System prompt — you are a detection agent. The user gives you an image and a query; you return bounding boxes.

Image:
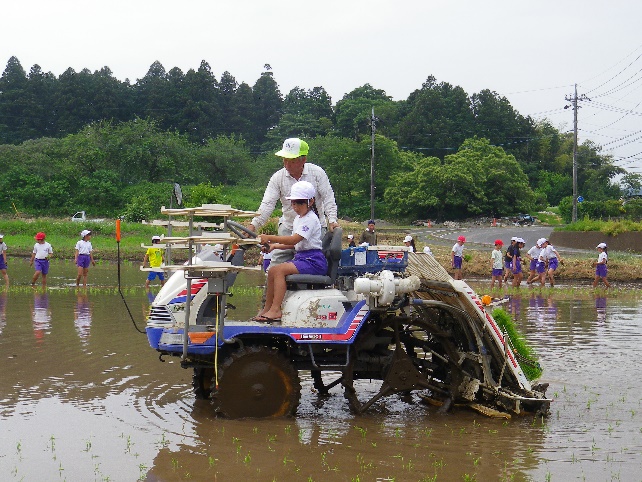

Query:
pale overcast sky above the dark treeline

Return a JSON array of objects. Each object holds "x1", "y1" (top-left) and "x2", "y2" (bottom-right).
[{"x1": 0, "y1": 0, "x2": 642, "y2": 177}]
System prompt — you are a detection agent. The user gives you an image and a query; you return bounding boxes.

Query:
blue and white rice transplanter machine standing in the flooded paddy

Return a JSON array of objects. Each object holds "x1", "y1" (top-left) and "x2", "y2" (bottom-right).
[{"x1": 146, "y1": 203, "x2": 551, "y2": 418}]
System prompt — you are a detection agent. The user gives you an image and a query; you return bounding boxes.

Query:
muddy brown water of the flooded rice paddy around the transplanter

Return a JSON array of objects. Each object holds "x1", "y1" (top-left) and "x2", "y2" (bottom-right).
[{"x1": 0, "y1": 266, "x2": 642, "y2": 481}]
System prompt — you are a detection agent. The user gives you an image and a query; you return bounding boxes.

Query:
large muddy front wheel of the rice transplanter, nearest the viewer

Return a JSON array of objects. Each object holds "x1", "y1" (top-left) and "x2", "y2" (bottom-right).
[{"x1": 212, "y1": 346, "x2": 301, "y2": 418}]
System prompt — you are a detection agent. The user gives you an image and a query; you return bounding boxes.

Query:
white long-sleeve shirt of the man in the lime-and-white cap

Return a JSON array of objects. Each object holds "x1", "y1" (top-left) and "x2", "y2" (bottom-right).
[{"x1": 252, "y1": 162, "x2": 337, "y2": 231}]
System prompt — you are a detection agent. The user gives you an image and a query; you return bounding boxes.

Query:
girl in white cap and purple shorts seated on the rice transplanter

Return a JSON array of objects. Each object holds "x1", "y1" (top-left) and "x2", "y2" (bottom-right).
[{"x1": 253, "y1": 181, "x2": 328, "y2": 323}]
